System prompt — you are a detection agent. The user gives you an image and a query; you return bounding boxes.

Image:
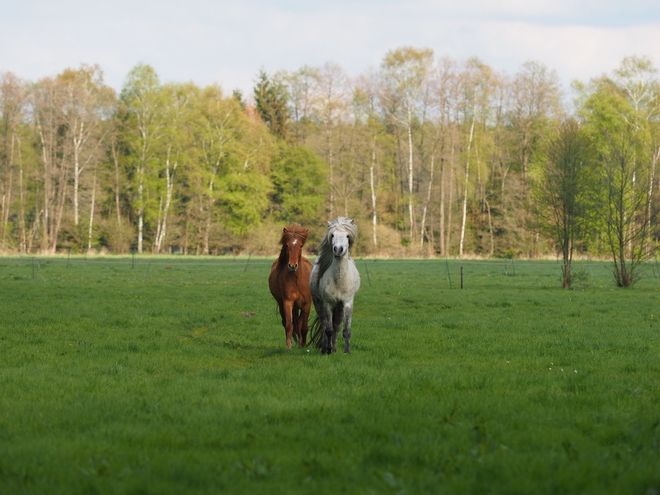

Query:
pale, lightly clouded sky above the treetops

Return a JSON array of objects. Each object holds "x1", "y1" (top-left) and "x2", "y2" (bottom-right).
[{"x1": 0, "y1": 0, "x2": 660, "y2": 95}]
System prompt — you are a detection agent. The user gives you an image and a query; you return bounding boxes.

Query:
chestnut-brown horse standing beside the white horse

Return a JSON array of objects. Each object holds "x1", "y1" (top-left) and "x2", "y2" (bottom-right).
[{"x1": 268, "y1": 225, "x2": 312, "y2": 349}]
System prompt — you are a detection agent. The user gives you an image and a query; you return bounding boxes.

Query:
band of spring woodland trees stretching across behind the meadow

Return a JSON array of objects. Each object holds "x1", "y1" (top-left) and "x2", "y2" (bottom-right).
[{"x1": 0, "y1": 47, "x2": 660, "y2": 276}]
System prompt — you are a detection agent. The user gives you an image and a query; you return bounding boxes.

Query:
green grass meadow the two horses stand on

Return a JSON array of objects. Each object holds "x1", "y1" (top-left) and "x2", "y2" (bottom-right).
[{"x1": 0, "y1": 257, "x2": 660, "y2": 495}]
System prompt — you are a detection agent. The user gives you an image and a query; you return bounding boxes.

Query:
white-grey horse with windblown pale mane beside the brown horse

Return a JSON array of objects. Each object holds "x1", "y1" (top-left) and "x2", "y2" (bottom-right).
[{"x1": 309, "y1": 217, "x2": 360, "y2": 354}]
